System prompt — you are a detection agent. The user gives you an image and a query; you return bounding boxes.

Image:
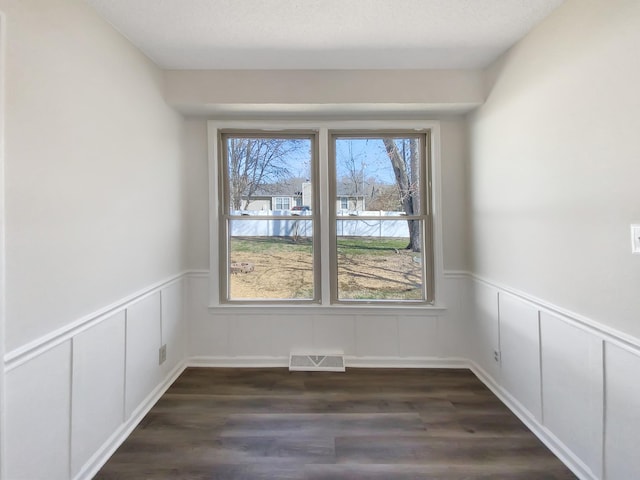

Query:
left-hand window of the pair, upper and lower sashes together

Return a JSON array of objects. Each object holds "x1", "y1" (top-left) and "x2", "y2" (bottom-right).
[{"x1": 220, "y1": 132, "x2": 319, "y2": 301}]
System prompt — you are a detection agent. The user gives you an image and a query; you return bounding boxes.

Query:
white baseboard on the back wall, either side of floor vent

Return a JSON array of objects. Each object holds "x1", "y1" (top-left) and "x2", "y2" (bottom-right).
[{"x1": 186, "y1": 356, "x2": 469, "y2": 368}]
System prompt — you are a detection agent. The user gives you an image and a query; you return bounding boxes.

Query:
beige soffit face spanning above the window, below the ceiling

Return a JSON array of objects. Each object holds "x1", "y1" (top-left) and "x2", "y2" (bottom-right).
[{"x1": 165, "y1": 70, "x2": 484, "y2": 118}]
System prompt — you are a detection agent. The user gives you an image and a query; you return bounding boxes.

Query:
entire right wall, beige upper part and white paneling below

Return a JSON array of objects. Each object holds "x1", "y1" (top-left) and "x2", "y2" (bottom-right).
[{"x1": 468, "y1": 0, "x2": 640, "y2": 480}]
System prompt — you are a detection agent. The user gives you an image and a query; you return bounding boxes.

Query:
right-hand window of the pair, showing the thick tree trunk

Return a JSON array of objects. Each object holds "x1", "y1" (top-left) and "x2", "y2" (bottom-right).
[{"x1": 332, "y1": 133, "x2": 426, "y2": 301}]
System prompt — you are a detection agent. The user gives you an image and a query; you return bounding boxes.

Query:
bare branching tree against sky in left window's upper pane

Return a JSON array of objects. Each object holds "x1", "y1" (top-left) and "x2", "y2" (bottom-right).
[{"x1": 227, "y1": 137, "x2": 305, "y2": 210}]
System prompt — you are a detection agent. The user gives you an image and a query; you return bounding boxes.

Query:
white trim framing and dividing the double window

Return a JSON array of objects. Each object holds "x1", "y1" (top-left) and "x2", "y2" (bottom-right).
[{"x1": 207, "y1": 120, "x2": 444, "y2": 315}]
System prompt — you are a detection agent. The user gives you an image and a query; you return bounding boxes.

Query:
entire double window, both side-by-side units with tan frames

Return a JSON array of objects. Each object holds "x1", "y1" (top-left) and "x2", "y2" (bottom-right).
[{"x1": 212, "y1": 125, "x2": 436, "y2": 306}]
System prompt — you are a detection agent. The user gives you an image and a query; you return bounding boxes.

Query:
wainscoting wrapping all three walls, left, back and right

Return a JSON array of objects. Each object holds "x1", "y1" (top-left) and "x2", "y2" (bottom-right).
[{"x1": 3, "y1": 272, "x2": 640, "y2": 480}]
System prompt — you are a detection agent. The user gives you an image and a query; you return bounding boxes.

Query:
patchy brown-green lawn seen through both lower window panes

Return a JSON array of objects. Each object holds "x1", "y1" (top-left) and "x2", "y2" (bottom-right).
[{"x1": 230, "y1": 237, "x2": 423, "y2": 300}]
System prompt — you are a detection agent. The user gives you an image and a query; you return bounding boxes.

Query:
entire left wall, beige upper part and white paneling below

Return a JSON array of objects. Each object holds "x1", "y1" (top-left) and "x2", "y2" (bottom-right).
[{"x1": 0, "y1": 0, "x2": 187, "y2": 480}]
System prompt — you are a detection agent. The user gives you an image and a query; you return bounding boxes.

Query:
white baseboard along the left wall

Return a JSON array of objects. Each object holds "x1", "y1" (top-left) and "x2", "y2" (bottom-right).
[{"x1": 73, "y1": 362, "x2": 187, "y2": 480}]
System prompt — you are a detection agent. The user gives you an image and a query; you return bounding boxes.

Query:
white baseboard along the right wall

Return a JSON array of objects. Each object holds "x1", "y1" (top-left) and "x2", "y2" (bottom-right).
[{"x1": 467, "y1": 360, "x2": 598, "y2": 480}]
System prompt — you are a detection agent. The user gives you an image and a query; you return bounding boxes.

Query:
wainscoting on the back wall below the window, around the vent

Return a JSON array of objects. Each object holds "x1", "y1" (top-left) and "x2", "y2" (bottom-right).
[{"x1": 188, "y1": 273, "x2": 468, "y2": 367}]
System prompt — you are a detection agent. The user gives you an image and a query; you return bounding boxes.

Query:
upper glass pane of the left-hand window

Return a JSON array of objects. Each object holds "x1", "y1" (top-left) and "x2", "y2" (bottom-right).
[{"x1": 223, "y1": 135, "x2": 313, "y2": 215}]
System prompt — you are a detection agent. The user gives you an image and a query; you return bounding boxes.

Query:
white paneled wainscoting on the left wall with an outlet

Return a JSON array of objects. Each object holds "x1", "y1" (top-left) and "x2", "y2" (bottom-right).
[{"x1": 5, "y1": 275, "x2": 186, "y2": 480}]
